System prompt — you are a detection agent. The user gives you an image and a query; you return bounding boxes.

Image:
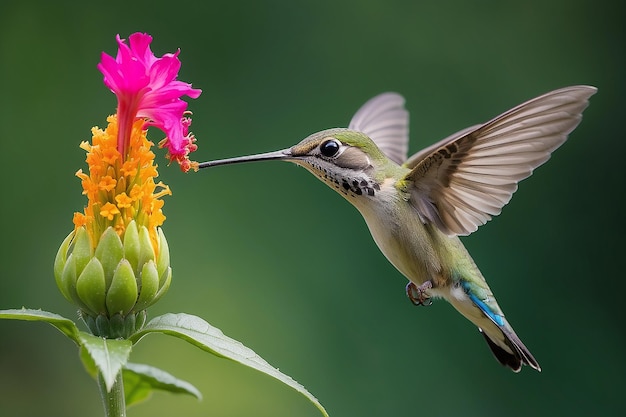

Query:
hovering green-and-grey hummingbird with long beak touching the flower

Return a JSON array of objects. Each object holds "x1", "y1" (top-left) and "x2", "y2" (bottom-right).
[{"x1": 199, "y1": 86, "x2": 596, "y2": 372}]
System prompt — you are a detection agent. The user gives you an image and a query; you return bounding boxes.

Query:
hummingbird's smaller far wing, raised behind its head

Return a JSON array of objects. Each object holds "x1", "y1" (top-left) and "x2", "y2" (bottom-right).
[{"x1": 348, "y1": 93, "x2": 409, "y2": 164}]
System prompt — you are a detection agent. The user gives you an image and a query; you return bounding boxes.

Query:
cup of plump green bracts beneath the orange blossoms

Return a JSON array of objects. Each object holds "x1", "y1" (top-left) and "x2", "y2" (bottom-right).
[{"x1": 54, "y1": 221, "x2": 172, "y2": 338}]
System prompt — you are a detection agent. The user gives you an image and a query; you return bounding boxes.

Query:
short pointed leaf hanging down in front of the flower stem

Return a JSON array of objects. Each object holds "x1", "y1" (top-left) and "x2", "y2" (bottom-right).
[{"x1": 78, "y1": 332, "x2": 133, "y2": 391}]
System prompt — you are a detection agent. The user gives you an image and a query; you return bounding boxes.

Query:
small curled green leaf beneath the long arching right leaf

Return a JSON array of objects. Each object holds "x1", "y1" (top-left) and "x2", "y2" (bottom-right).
[{"x1": 122, "y1": 363, "x2": 202, "y2": 405}]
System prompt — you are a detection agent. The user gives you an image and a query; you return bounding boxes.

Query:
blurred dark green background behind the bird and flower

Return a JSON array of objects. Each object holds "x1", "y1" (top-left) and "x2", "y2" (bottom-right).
[{"x1": 0, "y1": 0, "x2": 626, "y2": 417}]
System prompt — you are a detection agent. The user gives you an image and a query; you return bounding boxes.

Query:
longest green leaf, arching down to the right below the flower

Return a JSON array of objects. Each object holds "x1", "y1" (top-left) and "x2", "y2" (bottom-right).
[{"x1": 130, "y1": 313, "x2": 328, "y2": 417}]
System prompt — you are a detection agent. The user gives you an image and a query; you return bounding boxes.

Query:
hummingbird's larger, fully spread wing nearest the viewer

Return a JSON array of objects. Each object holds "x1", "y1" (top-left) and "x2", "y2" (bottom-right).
[{"x1": 405, "y1": 86, "x2": 596, "y2": 235}]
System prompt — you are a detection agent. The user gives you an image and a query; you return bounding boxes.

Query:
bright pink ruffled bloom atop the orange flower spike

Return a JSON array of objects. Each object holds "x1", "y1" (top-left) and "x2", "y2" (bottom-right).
[{"x1": 98, "y1": 33, "x2": 202, "y2": 172}]
